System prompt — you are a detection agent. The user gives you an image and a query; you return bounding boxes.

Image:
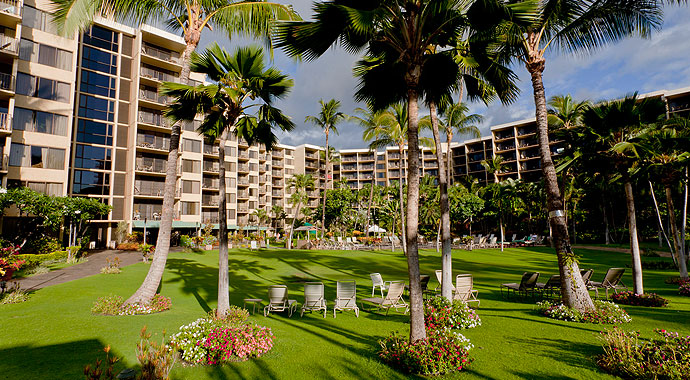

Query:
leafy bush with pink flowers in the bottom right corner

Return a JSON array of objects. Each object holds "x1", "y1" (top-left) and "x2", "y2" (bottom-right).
[{"x1": 597, "y1": 328, "x2": 690, "y2": 379}]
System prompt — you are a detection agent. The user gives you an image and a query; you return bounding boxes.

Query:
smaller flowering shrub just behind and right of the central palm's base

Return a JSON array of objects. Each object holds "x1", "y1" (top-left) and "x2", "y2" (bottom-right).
[{"x1": 424, "y1": 297, "x2": 482, "y2": 330}]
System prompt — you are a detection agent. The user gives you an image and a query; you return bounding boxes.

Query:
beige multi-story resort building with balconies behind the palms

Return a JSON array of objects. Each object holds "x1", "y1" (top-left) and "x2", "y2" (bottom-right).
[{"x1": 0, "y1": 0, "x2": 690, "y2": 246}]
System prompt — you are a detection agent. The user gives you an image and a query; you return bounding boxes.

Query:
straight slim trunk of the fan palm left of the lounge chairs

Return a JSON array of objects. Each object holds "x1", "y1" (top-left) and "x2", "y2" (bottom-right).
[{"x1": 216, "y1": 130, "x2": 230, "y2": 317}]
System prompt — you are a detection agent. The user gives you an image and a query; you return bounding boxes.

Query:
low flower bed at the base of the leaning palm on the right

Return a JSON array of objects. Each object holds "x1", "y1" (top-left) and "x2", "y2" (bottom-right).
[{"x1": 537, "y1": 300, "x2": 632, "y2": 324}]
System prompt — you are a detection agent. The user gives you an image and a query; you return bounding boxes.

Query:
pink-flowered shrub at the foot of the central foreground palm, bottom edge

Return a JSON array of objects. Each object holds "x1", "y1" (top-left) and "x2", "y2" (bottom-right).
[{"x1": 378, "y1": 329, "x2": 473, "y2": 375}]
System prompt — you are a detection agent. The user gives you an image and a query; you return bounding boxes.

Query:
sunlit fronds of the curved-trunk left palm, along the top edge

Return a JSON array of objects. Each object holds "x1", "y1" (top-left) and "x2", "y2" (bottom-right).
[{"x1": 54, "y1": 0, "x2": 300, "y2": 45}]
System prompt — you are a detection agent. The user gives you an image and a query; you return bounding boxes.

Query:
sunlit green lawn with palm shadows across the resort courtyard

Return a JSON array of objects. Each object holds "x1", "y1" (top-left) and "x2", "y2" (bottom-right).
[{"x1": 0, "y1": 248, "x2": 690, "y2": 380}]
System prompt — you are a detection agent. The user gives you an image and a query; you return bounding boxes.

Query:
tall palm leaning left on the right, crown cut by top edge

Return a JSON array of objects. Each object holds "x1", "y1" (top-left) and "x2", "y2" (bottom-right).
[{"x1": 472, "y1": 0, "x2": 662, "y2": 311}]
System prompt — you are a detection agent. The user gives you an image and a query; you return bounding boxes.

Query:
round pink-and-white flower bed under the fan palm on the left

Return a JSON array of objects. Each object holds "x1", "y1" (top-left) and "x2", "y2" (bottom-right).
[{"x1": 168, "y1": 306, "x2": 275, "y2": 365}]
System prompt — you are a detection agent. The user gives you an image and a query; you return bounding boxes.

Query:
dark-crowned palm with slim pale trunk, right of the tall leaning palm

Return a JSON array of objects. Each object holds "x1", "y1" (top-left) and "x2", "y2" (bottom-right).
[{"x1": 574, "y1": 94, "x2": 665, "y2": 294}]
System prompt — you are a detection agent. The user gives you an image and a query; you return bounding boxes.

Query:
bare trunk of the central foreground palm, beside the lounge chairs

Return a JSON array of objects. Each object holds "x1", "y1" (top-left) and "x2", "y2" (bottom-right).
[{"x1": 406, "y1": 81, "x2": 426, "y2": 342}]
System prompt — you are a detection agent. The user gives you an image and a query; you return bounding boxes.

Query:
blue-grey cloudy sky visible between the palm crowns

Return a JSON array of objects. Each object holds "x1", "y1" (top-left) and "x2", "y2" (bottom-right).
[{"x1": 200, "y1": 0, "x2": 690, "y2": 149}]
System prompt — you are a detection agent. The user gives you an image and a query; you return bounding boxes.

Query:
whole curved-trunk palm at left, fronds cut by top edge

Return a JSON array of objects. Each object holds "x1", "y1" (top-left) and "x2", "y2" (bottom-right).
[{"x1": 54, "y1": 0, "x2": 300, "y2": 304}]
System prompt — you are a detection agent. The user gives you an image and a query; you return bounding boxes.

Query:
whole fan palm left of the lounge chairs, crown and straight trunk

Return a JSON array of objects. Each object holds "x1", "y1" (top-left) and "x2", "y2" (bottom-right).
[{"x1": 161, "y1": 44, "x2": 294, "y2": 315}]
